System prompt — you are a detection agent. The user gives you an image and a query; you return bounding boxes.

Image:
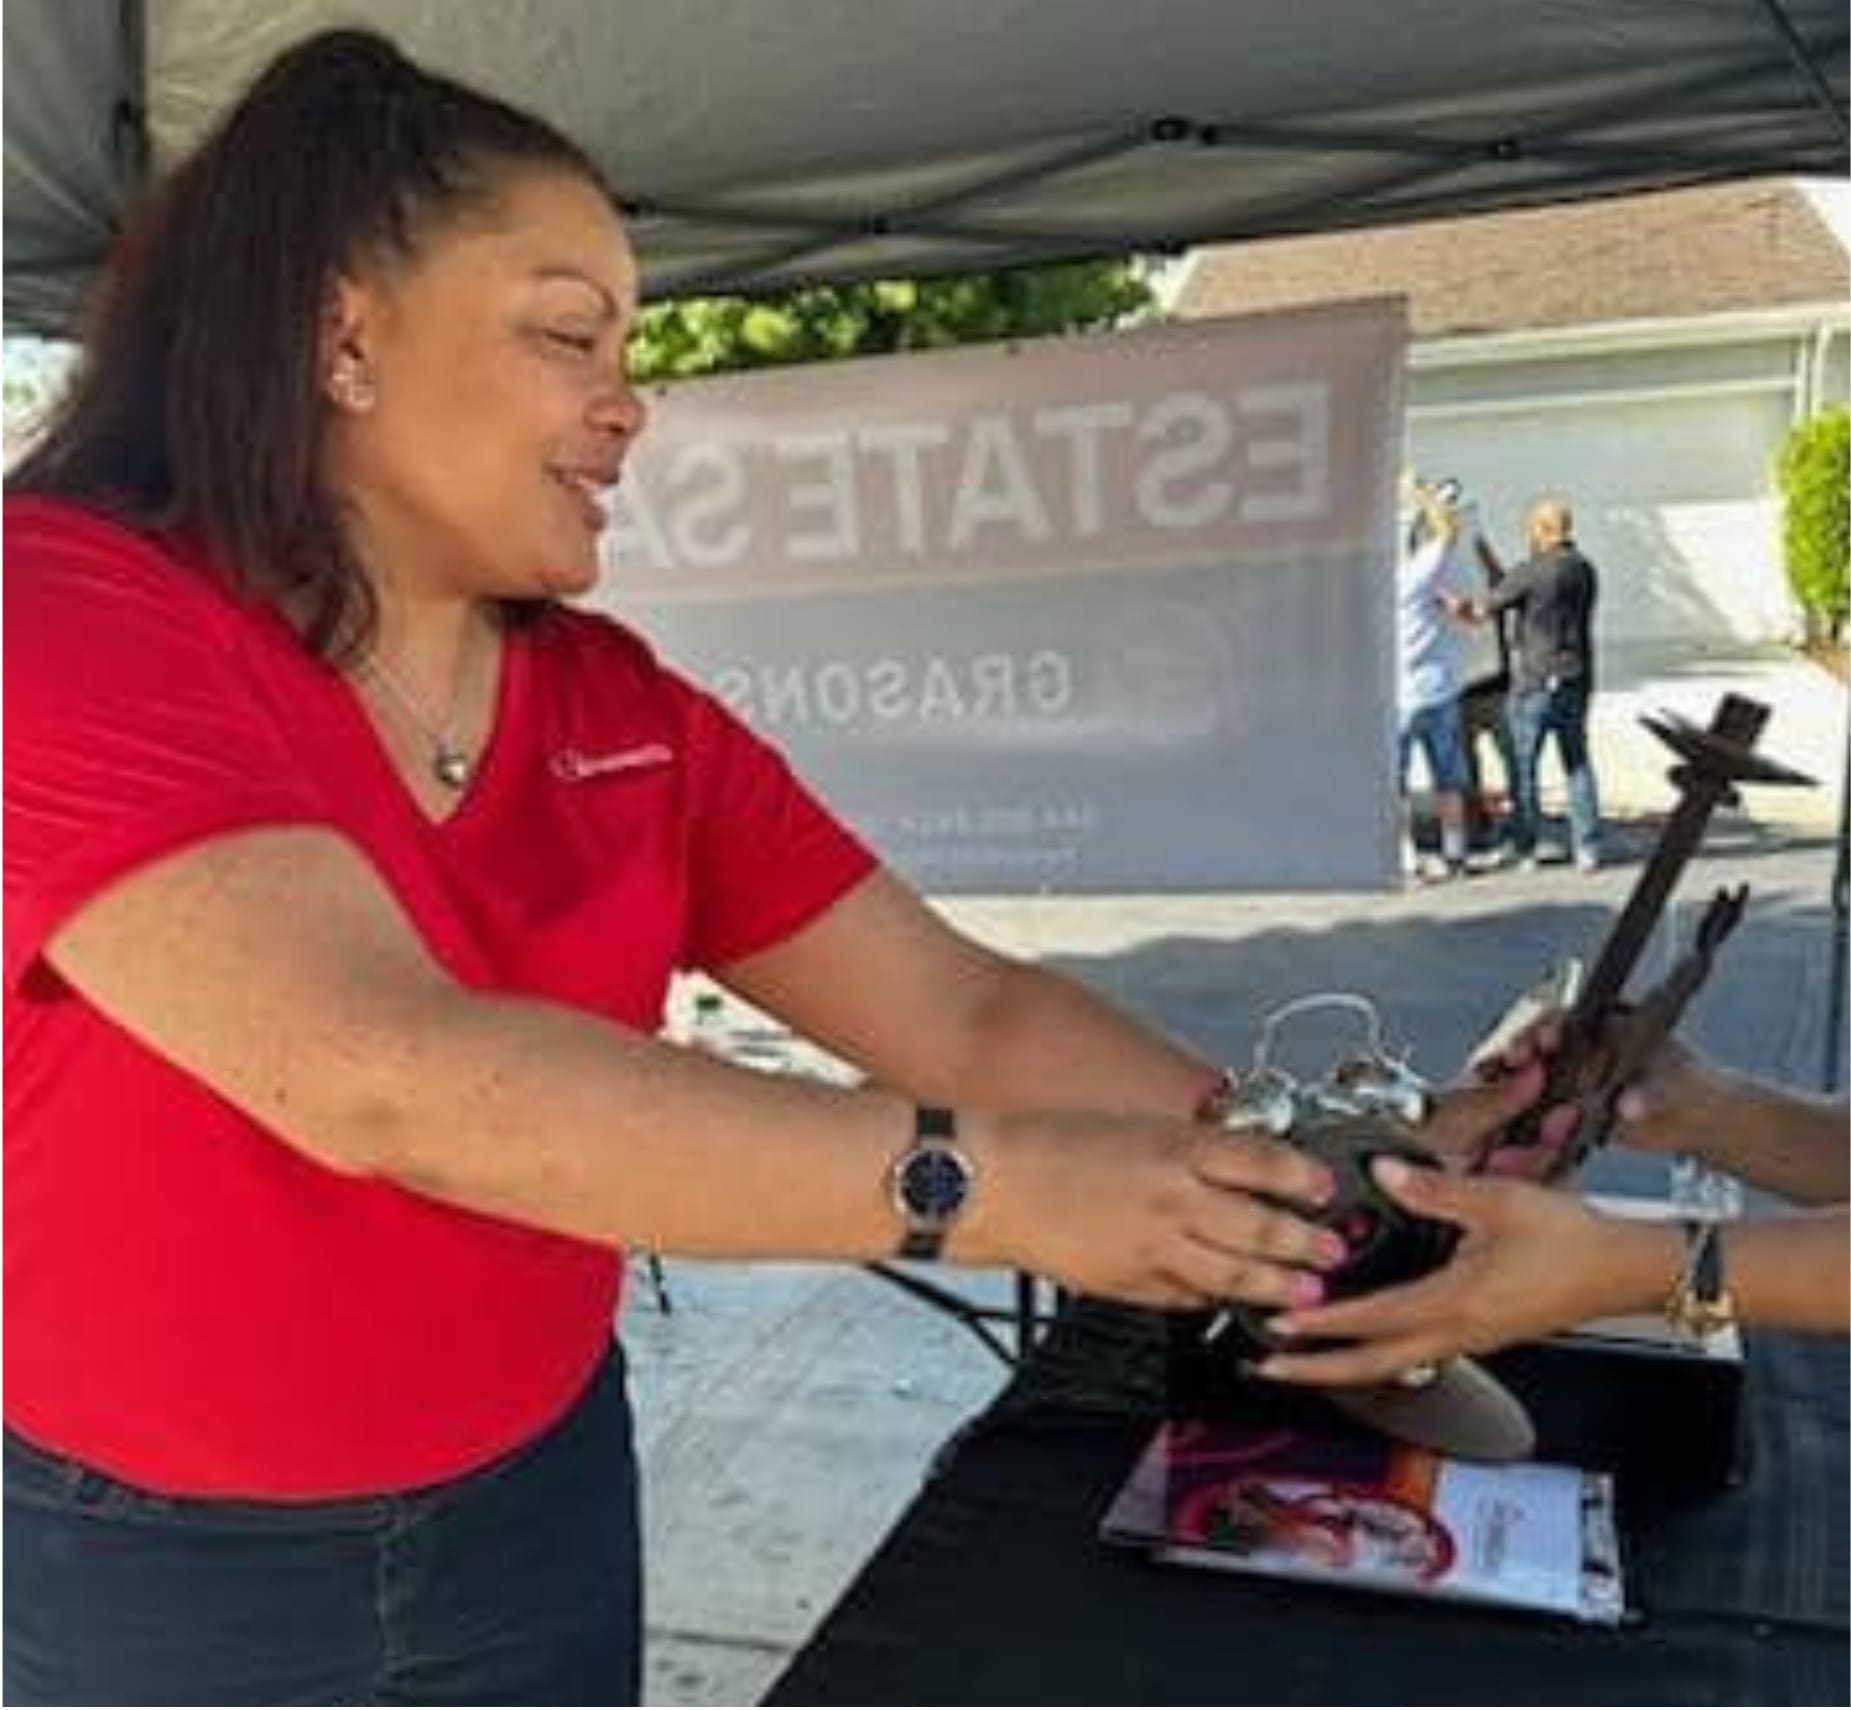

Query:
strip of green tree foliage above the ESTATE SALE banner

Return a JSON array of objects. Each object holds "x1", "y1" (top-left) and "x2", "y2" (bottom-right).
[{"x1": 629, "y1": 261, "x2": 1153, "y2": 381}]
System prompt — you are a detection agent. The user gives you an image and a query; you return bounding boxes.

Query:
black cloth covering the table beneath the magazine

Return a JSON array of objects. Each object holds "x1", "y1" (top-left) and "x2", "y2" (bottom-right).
[{"x1": 766, "y1": 1301, "x2": 1851, "y2": 1704}]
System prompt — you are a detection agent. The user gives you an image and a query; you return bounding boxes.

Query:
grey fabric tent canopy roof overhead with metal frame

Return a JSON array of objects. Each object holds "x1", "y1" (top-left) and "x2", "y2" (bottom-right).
[{"x1": 6, "y1": 0, "x2": 1851, "y2": 331}]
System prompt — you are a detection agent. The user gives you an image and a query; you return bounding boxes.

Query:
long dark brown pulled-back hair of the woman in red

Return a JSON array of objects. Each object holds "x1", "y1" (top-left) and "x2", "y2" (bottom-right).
[{"x1": 6, "y1": 30, "x2": 615, "y2": 657}]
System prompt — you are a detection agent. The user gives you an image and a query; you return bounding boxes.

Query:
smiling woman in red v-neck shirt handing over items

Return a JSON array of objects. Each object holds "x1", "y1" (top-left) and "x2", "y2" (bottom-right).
[{"x1": 6, "y1": 31, "x2": 1532, "y2": 1703}]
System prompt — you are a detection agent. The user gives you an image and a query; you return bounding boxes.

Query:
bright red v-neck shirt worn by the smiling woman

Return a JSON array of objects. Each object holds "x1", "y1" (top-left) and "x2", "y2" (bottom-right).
[{"x1": 6, "y1": 498, "x2": 874, "y2": 1499}]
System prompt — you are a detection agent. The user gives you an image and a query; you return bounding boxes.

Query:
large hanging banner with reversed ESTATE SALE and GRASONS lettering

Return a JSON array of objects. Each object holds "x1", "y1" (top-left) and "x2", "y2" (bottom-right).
[{"x1": 607, "y1": 304, "x2": 1401, "y2": 894}]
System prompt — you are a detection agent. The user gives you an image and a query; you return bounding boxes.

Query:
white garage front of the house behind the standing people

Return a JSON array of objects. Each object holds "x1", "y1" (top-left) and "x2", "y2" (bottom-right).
[{"x1": 1409, "y1": 305, "x2": 1851, "y2": 650}]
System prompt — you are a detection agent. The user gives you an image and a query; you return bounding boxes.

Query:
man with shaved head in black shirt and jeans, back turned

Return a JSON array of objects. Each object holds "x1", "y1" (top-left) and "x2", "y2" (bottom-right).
[{"x1": 1457, "y1": 498, "x2": 1601, "y2": 872}]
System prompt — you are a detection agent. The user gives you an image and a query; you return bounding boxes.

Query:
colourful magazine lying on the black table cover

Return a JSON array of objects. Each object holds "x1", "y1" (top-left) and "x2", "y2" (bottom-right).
[{"x1": 1099, "y1": 1421, "x2": 1625, "y2": 1625}]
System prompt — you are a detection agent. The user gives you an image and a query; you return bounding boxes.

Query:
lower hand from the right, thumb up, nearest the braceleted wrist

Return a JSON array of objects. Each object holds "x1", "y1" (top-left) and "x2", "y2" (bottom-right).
[{"x1": 1257, "y1": 1159, "x2": 1681, "y2": 1386}]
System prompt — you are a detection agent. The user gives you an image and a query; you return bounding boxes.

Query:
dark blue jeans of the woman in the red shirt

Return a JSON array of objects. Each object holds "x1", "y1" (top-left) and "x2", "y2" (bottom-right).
[{"x1": 4, "y1": 1347, "x2": 642, "y2": 1704}]
